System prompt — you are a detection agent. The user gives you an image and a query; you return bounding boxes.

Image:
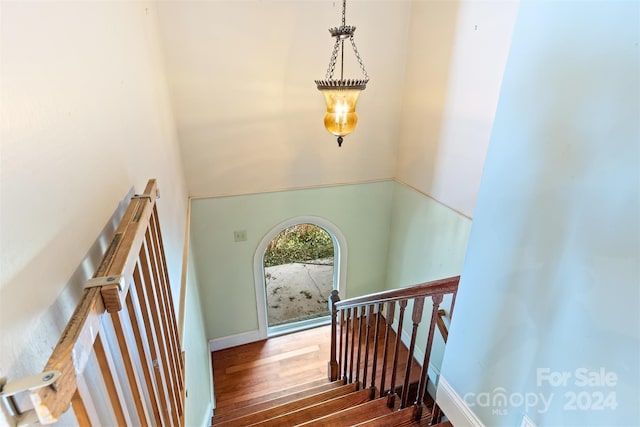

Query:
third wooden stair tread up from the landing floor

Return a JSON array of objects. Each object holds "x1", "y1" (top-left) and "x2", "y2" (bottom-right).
[{"x1": 252, "y1": 389, "x2": 371, "y2": 427}]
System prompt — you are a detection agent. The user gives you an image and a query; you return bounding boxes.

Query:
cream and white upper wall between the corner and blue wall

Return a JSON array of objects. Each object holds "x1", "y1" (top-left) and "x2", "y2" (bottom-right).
[{"x1": 396, "y1": 0, "x2": 518, "y2": 217}]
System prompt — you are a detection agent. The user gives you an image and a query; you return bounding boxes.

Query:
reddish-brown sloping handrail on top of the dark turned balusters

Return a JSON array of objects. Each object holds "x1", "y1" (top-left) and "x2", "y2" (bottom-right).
[{"x1": 336, "y1": 276, "x2": 460, "y2": 309}]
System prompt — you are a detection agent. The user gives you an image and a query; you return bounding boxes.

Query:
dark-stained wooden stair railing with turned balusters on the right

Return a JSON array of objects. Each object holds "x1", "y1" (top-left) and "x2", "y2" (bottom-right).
[{"x1": 328, "y1": 276, "x2": 460, "y2": 419}]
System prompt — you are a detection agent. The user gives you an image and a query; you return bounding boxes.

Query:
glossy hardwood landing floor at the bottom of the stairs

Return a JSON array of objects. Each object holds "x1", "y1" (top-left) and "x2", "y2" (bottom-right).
[{"x1": 212, "y1": 326, "x2": 420, "y2": 414}]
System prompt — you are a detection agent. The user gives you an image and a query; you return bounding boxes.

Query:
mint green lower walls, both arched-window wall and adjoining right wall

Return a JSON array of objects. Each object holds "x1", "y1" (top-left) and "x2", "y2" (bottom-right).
[{"x1": 191, "y1": 181, "x2": 471, "y2": 364}]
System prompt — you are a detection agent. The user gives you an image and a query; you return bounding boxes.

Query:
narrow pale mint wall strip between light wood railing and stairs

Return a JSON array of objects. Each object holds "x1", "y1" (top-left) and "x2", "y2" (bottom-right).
[{"x1": 182, "y1": 244, "x2": 214, "y2": 426}]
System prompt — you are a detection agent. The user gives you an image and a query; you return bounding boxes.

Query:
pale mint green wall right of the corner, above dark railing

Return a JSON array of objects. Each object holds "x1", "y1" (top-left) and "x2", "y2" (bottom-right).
[{"x1": 386, "y1": 183, "x2": 471, "y2": 381}]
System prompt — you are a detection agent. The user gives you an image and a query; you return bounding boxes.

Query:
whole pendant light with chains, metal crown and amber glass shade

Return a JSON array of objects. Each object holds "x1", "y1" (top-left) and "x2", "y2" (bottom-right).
[{"x1": 315, "y1": 0, "x2": 369, "y2": 147}]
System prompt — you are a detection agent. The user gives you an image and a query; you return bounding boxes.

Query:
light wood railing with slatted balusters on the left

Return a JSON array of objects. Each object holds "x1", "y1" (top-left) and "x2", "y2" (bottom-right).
[{"x1": 0, "y1": 180, "x2": 185, "y2": 426}]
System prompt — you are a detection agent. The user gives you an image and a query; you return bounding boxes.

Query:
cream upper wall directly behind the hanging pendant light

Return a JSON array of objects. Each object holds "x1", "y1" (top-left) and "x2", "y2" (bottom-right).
[{"x1": 158, "y1": 0, "x2": 411, "y2": 197}]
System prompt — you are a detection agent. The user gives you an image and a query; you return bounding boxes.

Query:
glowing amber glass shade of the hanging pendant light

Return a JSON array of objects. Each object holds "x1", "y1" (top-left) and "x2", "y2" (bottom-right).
[{"x1": 321, "y1": 88, "x2": 361, "y2": 137}]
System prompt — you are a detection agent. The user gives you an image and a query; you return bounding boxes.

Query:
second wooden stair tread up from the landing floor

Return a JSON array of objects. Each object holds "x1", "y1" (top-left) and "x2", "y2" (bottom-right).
[{"x1": 214, "y1": 383, "x2": 358, "y2": 427}]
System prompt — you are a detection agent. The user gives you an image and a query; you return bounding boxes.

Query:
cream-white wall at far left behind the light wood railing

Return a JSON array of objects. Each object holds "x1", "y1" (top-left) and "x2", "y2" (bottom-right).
[{"x1": 0, "y1": 2, "x2": 204, "y2": 424}]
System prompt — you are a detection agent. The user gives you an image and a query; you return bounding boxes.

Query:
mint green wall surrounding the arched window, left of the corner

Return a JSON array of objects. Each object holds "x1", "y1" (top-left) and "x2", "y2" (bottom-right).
[{"x1": 191, "y1": 181, "x2": 394, "y2": 339}]
